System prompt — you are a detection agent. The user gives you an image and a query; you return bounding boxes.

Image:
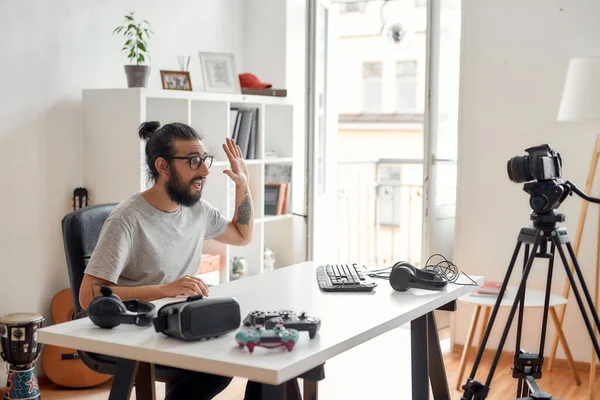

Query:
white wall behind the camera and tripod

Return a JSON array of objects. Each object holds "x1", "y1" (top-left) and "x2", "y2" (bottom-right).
[{"x1": 454, "y1": 0, "x2": 600, "y2": 368}]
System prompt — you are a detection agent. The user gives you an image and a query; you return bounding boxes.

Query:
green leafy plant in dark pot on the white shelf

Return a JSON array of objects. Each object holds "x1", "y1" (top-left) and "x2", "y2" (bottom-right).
[{"x1": 113, "y1": 12, "x2": 154, "y2": 87}]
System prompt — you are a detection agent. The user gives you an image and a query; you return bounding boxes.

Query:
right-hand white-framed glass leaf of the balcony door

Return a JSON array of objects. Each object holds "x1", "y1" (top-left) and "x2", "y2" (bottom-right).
[{"x1": 423, "y1": 0, "x2": 461, "y2": 261}]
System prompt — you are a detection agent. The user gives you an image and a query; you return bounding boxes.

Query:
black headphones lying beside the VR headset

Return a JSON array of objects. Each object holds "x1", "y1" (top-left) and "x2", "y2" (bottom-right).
[{"x1": 88, "y1": 286, "x2": 156, "y2": 329}]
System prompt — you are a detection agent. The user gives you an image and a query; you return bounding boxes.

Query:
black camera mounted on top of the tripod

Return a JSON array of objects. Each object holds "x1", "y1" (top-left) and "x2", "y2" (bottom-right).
[{"x1": 506, "y1": 144, "x2": 562, "y2": 183}]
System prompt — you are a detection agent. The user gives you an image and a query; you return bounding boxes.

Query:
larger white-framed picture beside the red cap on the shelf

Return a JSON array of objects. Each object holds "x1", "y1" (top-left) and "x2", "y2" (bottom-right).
[{"x1": 200, "y1": 53, "x2": 241, "y2": 93}]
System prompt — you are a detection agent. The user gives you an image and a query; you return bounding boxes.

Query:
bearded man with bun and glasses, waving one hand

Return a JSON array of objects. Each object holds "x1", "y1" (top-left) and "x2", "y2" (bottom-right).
[{"x1": 79, "y1": 121, "x2": 260, "y2": 400}]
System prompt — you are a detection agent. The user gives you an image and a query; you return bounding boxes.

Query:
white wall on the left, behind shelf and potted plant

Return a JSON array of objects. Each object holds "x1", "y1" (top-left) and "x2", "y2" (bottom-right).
[{"x1": 0, "y1": 0, "x2": 245, "y2": 376}]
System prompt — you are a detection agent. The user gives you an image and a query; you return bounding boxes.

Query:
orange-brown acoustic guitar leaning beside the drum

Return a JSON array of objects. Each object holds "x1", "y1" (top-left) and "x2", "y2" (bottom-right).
[{"x1": 42, "y1": 289, "x2": 112, "y2": 388}]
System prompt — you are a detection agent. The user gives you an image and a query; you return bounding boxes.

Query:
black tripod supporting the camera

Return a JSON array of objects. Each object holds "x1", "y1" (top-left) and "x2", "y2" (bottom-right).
[{"x1": 461, "y1": 181, "x2": 600, "y2": 400}]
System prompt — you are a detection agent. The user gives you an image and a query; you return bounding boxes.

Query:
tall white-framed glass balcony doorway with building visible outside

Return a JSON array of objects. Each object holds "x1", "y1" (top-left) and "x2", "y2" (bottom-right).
[{"x1": 307, "y1": 0, "x2": 460, "y2": 282}]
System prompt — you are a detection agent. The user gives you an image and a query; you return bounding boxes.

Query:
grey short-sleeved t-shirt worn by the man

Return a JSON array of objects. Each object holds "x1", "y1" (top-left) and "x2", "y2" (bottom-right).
[{"x1": 85, "y1": 193, "x2": 227, "y2": 286}]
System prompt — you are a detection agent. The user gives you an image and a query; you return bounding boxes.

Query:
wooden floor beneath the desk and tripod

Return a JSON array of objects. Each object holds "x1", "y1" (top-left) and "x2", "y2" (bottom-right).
[{"x1": 19, "y1": 327, "x2": 600, "y2": 400}]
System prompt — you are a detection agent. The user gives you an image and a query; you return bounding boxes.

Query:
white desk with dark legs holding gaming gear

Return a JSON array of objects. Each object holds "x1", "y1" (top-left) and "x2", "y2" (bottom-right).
[{"x1": 38, "y1": 262, "x2": 483, "y2": 398}]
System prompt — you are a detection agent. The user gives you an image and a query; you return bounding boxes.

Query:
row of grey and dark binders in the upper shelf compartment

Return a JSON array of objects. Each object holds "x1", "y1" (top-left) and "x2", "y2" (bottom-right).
[{"x1": 229, "y1": 107, "x2": 259, "y2": 160}]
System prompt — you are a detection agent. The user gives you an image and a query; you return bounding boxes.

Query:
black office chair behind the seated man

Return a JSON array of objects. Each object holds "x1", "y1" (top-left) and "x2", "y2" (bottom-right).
[{"x1": 62, "y1": 203, "x2": 176, "y2": 385}]
